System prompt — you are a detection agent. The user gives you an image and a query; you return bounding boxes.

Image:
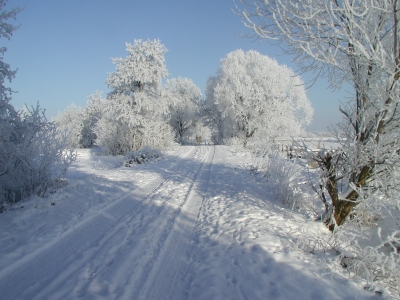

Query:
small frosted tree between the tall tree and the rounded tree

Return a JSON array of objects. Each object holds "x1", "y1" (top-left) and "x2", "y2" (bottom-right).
[{"x1": 164, "y1": 77, "x2": 202, "y2": 143}]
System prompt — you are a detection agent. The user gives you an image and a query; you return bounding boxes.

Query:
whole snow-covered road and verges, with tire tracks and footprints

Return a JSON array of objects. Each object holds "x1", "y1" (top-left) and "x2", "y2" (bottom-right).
[{"x1": 0, "y1": 146, "x2": 373, "y2": 299}]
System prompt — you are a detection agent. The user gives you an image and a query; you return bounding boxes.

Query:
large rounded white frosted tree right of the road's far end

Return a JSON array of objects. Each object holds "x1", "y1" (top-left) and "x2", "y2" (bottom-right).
[{"x1": 207, "y1": 50, "x2": 313, "y2": 146}]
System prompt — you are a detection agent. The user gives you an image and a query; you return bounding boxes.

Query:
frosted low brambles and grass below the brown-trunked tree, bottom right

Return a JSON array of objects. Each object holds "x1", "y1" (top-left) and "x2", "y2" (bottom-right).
[{"x1": 296, "y1": 179, "x2": 400, "y2": 298}]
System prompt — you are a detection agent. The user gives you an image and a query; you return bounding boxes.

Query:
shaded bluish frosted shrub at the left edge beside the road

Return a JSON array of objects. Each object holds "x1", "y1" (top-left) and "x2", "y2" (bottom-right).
[{"x1": 0, "y1": 106, "x2": 76, "y2": 203}]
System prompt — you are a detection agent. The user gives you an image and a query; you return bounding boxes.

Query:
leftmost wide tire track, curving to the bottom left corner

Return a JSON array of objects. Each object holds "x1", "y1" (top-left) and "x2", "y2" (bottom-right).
[{"x1": 0, "y1": 148, "x2": 199, "y2": 299}]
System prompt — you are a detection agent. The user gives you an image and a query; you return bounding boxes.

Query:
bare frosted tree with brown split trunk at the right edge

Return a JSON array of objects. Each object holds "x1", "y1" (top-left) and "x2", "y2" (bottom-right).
[{"x1": 238, "y1": 0, "x2": 400, "y2": 230}]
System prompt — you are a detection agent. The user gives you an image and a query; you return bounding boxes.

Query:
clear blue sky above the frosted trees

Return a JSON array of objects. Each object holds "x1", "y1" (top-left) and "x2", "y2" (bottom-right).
[{"x1": 1, "y1": 0, "x2": 347, "y2": 131}]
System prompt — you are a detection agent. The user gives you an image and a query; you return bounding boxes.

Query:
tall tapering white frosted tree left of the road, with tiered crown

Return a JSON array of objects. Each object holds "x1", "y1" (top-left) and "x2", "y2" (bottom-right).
[{"x1": 93, "y1": 40, "x2": 173, "y2": 155}]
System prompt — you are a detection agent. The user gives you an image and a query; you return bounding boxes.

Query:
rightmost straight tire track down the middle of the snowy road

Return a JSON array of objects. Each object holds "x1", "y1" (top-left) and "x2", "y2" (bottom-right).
[{"x1": 133, "y1": 146, "x2": 215, "y2": 299}]
